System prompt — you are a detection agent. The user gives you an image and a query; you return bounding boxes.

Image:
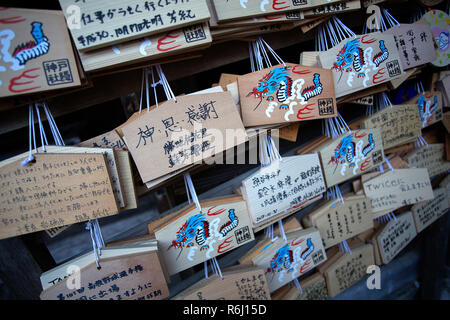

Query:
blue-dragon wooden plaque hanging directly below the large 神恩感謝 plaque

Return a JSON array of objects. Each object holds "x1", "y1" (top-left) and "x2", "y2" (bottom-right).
[{"x1": 154, "y1": 197, "x2": 254, "y2": 275}]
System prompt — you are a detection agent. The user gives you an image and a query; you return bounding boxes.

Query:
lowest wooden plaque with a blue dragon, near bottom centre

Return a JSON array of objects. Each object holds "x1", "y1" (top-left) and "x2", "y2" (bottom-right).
[{"x1": 252, "y1": 228, "x2": 327, "y2": 292}]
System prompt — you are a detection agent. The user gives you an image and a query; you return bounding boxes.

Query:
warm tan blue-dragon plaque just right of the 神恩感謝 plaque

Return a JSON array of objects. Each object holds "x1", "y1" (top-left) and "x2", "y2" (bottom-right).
[{"x1": 238, "y1": 63, "x2": 337, "y2": 127}]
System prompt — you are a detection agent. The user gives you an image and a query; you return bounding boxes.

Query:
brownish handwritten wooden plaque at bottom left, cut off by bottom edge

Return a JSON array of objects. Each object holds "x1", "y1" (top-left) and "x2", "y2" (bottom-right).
[{"x1": 41, "y1": 251, "x2": 169, "y2": 300}]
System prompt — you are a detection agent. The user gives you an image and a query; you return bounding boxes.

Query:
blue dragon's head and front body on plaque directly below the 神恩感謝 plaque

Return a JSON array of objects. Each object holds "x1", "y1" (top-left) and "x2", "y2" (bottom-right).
[{"x1": 167, "y1": 213, "x2": 210, "y2": 256}]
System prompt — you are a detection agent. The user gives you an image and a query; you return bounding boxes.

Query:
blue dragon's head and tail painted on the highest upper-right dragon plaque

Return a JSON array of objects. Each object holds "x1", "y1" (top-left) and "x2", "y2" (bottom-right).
[{"x1": 332, "y1": 39, "x2": 389, "y2": 78}]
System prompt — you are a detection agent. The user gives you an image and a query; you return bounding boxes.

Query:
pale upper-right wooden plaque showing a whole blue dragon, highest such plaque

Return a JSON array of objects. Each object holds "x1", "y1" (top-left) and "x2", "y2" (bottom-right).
[{"x1": 319, "y1": 32, "x2": 403, "y2": 98}]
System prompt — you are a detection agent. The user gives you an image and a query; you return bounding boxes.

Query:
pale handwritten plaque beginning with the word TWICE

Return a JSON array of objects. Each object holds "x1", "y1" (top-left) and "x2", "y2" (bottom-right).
[{"x1": 363, "y1": 168, "x2": 433, "y2": 212}]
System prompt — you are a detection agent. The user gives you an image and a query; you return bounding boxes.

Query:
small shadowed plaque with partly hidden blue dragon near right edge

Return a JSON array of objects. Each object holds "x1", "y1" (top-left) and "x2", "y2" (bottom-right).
[{"x1": 407, "y1": 91, "x2": 443, "y2": 128}]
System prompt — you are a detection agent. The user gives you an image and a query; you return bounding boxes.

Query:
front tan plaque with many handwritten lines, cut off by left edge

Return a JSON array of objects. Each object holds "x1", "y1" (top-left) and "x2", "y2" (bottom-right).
[{"x1": 0, "y1": 153, "x2": 118, "y2": 239}]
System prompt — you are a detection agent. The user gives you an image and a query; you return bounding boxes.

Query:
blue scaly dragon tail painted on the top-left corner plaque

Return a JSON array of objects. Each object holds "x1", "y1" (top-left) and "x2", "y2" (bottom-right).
[{"x1": 12, "y1": 22, "x2": 50, "y2": 65}]
